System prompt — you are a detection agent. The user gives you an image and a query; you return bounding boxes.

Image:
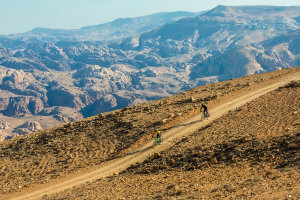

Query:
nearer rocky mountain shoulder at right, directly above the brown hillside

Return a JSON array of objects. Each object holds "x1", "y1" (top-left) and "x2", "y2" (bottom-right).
[{"x1": 190, "y1": 30, "x2": 300, "y2": 81}]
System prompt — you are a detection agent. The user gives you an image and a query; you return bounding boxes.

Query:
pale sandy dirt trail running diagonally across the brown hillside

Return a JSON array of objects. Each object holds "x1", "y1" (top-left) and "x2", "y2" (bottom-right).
[{"x1": 11, "y1": 73, "x2": 300, "y2": 200}]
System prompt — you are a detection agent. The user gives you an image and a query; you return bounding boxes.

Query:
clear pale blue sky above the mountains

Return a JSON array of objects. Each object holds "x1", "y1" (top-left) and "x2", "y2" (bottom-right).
[{"x1": 0, "y1": 0, "x2": 300, "y2": 35}]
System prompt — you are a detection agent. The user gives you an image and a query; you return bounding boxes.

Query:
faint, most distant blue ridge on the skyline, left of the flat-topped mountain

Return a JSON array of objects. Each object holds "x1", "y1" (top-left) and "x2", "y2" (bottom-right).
[{"x1": 1, "y1": 11, "x2": 203, "y2": 43}]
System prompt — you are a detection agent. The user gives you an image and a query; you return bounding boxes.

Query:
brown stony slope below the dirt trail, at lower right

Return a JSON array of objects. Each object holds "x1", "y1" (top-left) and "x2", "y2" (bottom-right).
[{"x1": 48, "y1": 82, "x2": 300, "y2": 200}]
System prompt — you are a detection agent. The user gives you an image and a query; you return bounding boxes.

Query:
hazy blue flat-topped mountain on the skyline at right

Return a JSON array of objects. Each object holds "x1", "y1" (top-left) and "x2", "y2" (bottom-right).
[{"x1": 115, "y1": 6, "x2": 300, "y2": 53}]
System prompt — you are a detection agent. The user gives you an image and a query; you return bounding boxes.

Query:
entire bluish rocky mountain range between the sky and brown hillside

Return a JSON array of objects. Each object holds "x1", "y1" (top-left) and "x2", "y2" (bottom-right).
[{"x1": 0, "y1": 6, "x2": 300, "y2": 139}]
